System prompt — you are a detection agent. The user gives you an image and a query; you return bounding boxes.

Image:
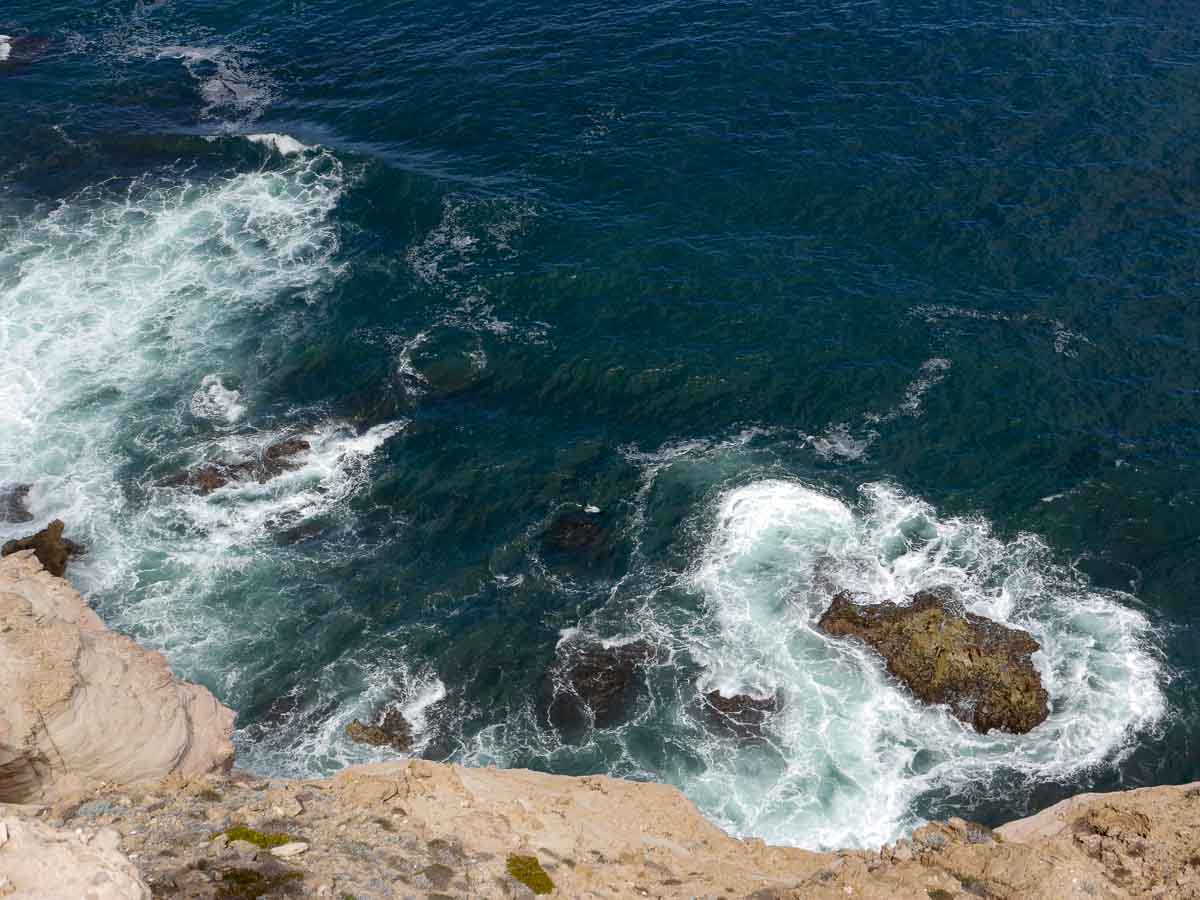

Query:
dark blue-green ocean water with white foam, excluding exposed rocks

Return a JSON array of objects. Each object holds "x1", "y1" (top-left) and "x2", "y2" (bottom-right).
[{"x1": 0, "y1": 0, "x2": 1200, "y2": 847}]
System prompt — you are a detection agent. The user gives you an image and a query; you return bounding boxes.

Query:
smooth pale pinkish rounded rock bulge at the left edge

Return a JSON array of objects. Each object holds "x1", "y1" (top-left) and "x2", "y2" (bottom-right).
[{"x1": 0, "y1": 550, "x2": 234, "y2": 803}]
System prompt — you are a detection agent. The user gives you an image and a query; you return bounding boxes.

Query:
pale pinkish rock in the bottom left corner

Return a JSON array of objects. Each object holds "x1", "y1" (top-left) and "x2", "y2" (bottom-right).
[{"x1": 0, "y1": 816, "x2": 150, "y2": 900}]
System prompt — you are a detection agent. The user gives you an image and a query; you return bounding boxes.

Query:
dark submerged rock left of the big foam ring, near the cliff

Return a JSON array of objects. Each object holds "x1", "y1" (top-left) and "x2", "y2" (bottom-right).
[{"x1": 550, "y1": 641, "x2": 654, "y2": 728}]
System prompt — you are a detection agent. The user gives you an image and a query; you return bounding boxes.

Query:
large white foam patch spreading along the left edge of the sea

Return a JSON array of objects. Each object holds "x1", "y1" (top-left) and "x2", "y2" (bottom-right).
[{"x1": 0, "y1": 151, "x2": 379, "y2": 673}]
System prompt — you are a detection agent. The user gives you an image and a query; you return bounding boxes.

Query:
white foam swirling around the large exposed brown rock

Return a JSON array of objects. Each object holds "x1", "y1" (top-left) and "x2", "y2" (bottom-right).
[{"x1": 680, "y1": 480, "x2": 1165, "y2": 847}]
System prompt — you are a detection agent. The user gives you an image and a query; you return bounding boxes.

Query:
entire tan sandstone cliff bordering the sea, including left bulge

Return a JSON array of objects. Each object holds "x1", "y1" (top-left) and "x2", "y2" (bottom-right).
[{"x1": 0, "y1": 552, "x2": 1200, "y2": 900}]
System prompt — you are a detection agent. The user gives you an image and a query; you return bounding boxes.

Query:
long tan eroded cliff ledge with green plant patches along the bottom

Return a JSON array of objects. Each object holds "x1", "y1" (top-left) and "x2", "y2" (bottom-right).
[{"x1": 9, "y1": 760, "x2": 1200, "y2": 900}]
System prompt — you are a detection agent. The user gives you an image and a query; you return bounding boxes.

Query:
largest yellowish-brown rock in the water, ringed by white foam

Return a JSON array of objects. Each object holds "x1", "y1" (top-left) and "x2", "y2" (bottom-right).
[{"x1": 817, "y1": 588, "x2": 1050, "y2": 734}]
